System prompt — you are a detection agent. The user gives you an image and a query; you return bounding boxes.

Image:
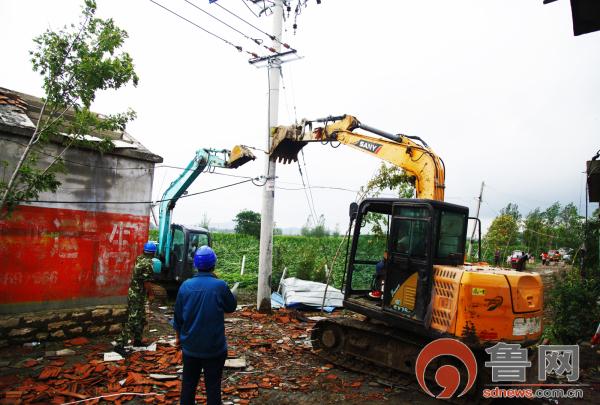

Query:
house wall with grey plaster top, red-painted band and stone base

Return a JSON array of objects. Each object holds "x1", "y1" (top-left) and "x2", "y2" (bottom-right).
[{"x1": 0, "y1": 89, "x2": 162, "y2": 344}]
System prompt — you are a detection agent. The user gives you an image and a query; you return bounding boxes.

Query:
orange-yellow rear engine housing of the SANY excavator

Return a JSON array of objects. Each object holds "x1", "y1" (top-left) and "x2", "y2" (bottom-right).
[{"x1": 430, "y1": 265, "x2": 543, "y2": 343}]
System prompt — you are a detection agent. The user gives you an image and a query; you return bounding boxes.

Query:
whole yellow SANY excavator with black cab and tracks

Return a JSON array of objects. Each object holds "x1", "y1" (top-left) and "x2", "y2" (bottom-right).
[{"x1": 270, "y1": 115, "x2": 543, "y2": 380}]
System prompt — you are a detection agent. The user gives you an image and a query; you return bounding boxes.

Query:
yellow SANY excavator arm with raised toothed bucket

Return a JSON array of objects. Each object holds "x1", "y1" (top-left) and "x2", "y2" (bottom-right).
[{"x1": 270, "y1": 115, "x2": 444, "y2": 201}]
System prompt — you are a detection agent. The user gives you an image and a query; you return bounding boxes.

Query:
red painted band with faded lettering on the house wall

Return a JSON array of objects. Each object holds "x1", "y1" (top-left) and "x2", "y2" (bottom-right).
[{"x1": 0, "y1": 206, "x2": 149, "y2": 304}]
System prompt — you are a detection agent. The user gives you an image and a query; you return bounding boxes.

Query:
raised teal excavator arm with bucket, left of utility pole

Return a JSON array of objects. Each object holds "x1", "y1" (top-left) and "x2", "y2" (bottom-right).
[{"x1": 158, "y1": 145, "x2": 256, "y2": 267}]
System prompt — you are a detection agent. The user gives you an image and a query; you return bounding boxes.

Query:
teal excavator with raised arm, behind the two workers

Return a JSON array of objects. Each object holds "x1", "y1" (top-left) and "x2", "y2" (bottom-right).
[{"x1": 152, "y1": 145, "x2": 256, "y2": 296}]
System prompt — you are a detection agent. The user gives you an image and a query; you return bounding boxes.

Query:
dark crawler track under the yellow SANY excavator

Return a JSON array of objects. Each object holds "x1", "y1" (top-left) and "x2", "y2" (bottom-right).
[{"x1": 311, "y1": 318, "x2": 494, "y2": 404}]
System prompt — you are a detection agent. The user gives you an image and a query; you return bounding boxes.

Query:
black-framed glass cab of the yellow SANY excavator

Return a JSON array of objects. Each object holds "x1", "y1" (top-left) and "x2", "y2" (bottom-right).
[{"x1": 344, "y1": 199, "x2": 468, "y2": 332}]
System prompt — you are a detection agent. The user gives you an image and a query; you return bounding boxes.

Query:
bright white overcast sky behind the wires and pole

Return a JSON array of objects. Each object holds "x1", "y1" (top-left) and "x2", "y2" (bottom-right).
[{"x1": 0, "y1": 0, "x2": 600, "y2": 229}]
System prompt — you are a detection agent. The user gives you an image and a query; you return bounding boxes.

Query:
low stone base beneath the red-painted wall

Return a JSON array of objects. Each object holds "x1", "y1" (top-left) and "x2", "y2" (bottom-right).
[{"x1": 0, "y1": 305, "x2": 127, "y2": 347}]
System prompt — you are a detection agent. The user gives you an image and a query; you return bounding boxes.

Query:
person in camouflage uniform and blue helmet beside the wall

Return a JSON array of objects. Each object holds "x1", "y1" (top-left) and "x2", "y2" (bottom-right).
[{"x1": 117, "y1": 242, "x2": 156, "y2": 350}]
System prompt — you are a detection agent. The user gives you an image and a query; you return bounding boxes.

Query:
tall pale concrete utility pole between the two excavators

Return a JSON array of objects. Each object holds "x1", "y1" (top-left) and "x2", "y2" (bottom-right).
[{"x1": 256, "y1": 0, "x2": 283, "y2": 313}]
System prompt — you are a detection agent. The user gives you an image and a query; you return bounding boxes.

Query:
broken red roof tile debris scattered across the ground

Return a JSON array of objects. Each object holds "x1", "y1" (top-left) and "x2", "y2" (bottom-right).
[{"x1": 0, "y1": 310, "x2": 408, "y2": 405}]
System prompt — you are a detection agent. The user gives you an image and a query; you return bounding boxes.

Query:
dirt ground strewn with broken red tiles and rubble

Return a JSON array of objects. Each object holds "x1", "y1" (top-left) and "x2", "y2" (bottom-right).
[{"x1": 0, "y1": 267, "x2": 600, "y2": 405}]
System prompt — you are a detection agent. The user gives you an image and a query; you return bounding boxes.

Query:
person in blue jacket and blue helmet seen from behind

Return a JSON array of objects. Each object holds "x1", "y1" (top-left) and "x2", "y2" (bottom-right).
[{"x1": 172, "y1": 246, "x2": 237, "y2": 405}]
